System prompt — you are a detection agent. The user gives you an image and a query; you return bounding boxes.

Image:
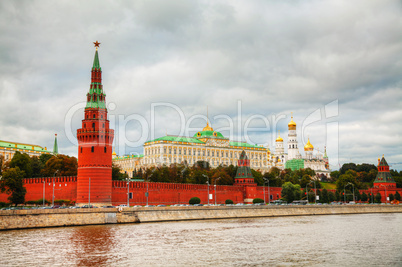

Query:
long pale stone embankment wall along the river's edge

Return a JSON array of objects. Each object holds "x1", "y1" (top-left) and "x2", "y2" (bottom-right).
[{"x1": 0, "y1": 205, "x2": 402, "y2": 230}]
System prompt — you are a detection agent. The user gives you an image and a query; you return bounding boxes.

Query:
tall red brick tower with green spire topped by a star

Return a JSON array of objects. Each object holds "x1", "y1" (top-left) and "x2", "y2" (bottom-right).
[{"x1": 77, "y1": 41, "x2": 114, "y2": 205}]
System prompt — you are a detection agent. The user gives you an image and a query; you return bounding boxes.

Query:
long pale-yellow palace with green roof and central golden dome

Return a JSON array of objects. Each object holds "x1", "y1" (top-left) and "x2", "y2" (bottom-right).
[{"x1": 113, "y1": 123, "x2": 271, "y2": 177}]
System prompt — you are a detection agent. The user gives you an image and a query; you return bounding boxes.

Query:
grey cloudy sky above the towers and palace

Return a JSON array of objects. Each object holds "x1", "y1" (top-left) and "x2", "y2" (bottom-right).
[{"x1": 0, "y1": 0, "x2": 402, "y2": 170}]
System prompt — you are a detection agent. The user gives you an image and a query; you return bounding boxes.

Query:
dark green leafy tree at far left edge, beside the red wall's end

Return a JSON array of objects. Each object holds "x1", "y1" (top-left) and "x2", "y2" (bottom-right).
[{"x1": 0, "y1": 166, "x2": 27, "y2": 205}]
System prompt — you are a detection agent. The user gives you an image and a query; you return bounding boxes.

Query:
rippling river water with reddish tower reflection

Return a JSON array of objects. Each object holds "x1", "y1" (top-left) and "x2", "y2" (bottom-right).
[{"x1": 0, "y1": 213, "x2": 402, "y2": 266}]
